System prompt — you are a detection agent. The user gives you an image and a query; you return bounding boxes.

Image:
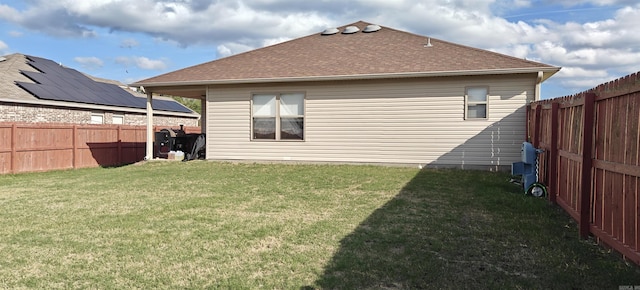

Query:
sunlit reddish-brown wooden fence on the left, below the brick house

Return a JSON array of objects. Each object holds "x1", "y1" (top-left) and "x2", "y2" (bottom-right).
[{"x1": 0, "y1": 123, "x2": 200, "y2": 174}]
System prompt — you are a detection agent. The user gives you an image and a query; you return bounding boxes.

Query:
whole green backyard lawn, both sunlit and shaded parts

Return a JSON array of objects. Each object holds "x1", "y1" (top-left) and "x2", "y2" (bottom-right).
[{"x1": 0, "y1": 161, "x2": 640, "y2": 289}]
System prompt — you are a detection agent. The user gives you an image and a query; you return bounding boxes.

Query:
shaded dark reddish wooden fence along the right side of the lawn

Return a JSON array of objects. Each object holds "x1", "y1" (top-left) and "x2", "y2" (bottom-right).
[{"x1": 527, "y1": 73, "x2": 640, "y2": 265}]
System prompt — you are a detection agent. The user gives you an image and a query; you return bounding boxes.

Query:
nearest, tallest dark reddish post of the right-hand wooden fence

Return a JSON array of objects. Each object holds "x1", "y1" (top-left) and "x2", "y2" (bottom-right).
[{"x1": 579, "y1": 93, "x2": 595, "y2": 239}]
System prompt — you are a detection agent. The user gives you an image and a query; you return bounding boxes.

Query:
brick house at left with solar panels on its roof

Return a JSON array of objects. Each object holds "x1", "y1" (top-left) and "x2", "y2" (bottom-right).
[{"x1": 0, "y1": 54, "x2": 200, "y2": 128}]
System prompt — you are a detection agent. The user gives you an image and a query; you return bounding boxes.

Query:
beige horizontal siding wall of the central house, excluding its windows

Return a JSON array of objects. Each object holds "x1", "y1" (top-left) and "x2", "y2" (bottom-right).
[{"x1": 206, "y1": 74, "x2": 536, "y2": 170}]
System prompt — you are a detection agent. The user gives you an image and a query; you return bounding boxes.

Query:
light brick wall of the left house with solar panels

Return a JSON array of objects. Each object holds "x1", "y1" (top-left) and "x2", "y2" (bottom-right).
[{"x1": 0, "y1": 103, "x2": 198, "y2": 127}]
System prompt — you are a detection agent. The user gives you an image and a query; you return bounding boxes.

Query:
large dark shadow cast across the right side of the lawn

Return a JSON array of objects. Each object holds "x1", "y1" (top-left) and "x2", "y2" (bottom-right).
[{"x1": 302, "y1": 170, "x2": 638, "y2": 289}]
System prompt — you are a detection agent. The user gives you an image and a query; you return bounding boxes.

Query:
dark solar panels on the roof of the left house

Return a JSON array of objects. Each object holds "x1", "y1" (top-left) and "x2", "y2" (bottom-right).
[{"x1": 16, "y1": 56, "x2": 191, "y2": 113}]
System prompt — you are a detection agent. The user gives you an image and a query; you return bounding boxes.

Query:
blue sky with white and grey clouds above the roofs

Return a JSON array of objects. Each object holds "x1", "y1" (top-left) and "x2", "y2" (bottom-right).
[{"x1": 0, "y1": 0, "x2": 640, "y2": 99}]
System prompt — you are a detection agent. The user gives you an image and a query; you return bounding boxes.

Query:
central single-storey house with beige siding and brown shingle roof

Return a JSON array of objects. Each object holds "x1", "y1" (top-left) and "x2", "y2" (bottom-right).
[{"x1": 133, "y1": 22, "x2": 560, "y2": 170}]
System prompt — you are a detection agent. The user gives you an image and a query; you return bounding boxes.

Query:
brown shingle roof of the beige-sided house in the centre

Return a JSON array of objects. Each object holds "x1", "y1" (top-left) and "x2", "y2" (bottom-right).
[{"x1": 134, "y1": 21, "x2": 559, "y2": 85}]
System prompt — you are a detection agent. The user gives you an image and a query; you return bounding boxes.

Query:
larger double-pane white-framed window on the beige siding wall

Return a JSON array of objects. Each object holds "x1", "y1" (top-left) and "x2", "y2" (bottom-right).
[{"x1": 251, "y1": 93, "x2": 304, "y2": 140}]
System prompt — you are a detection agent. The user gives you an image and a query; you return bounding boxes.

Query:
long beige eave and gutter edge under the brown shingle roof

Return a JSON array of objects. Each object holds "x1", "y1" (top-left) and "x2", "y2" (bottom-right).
[{"x1": 130, "y1": 66, "x2": 560, "y2": 88}]
